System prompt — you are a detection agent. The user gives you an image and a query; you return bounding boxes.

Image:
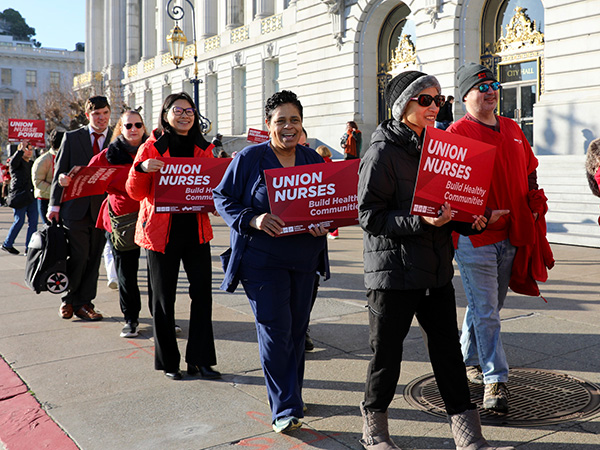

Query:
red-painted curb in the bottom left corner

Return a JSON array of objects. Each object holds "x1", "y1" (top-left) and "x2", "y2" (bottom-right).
[{"x1": 0, "y1": 358, "x2": 79, "y2": 450}]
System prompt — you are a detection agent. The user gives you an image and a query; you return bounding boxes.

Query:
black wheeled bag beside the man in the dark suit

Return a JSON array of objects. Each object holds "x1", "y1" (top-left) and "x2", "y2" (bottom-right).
[{"x1": 25, "y1": 221, "x2": 69, "y2": 294}]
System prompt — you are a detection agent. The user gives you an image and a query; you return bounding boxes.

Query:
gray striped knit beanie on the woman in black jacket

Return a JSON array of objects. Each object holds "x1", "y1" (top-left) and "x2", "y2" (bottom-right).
[{"x1": 383, "y1": 70, "x2": 442, "y2": 121}]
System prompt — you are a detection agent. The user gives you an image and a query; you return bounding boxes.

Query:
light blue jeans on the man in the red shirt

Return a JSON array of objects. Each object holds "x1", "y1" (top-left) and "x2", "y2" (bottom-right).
[{"x1": 454, "y1": 236, "x2": 516, "y2": 384}]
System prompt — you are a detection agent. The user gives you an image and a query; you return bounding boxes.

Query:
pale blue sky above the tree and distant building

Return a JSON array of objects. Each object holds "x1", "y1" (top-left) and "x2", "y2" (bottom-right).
[{"x1": 0, "y1": 0, "x2": 85, "y2": 50}]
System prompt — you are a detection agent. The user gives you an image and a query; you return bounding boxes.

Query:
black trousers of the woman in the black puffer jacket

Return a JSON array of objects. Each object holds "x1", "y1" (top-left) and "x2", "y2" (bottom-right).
[{"x1": 365, "y1": 282, "x2": 475, "y2": 414}]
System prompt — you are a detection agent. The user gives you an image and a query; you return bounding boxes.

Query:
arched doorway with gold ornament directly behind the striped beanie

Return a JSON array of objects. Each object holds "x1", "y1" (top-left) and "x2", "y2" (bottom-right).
[{"x1": 377, "y1": 3, "x2": 416, "y2": 123}]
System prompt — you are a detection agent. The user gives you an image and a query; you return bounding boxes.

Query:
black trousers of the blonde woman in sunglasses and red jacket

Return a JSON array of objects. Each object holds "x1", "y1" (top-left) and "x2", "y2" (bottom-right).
[{"x1": 107, "y1": 237, "x2": 142, "y2": 322}]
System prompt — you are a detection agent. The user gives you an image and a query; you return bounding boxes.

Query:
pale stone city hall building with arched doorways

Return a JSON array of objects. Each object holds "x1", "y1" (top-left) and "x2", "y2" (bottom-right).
[{"x1": 75, "y1": 0, "x2": 600, "y2": 246}]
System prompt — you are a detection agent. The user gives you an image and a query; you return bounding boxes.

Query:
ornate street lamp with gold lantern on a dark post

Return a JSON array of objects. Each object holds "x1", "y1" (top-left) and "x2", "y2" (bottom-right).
[{"x1": 167, "y1": 0, "x2": 211, "y2": 134}]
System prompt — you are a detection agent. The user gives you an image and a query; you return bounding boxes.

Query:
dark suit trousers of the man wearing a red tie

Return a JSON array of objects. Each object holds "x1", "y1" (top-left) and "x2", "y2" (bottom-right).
[{"x1": 62, "y1": 209, "x2": 106, "y2": 311}]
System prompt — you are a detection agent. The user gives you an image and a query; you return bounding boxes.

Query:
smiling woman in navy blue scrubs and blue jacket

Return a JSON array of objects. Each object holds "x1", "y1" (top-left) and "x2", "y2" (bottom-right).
[{"x1": 213, "y1": 91, "x2": 329, "y2": 433}]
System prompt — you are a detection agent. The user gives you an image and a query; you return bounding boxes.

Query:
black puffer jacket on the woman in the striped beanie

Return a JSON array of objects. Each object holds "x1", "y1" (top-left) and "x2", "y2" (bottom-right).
[{"x1": 358, "y1": 120, "x2": 477, "y2": 290}]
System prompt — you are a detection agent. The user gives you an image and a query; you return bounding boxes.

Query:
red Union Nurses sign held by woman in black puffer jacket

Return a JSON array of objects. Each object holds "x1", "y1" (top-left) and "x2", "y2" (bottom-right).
[{"x1": 411, "y1": 127, "x2": 496, "y2": 222}]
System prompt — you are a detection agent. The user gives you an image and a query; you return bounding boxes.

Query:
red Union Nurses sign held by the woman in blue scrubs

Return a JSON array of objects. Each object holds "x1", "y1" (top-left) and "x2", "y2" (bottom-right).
[{"x1": 265, "y1": 159, "x2": 360, "y2": 236}]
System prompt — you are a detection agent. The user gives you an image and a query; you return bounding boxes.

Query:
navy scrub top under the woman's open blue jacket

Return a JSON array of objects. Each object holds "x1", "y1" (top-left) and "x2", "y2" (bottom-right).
[{"x1": 242, "y1": 146, "x2": 325, "y2": 271}]
